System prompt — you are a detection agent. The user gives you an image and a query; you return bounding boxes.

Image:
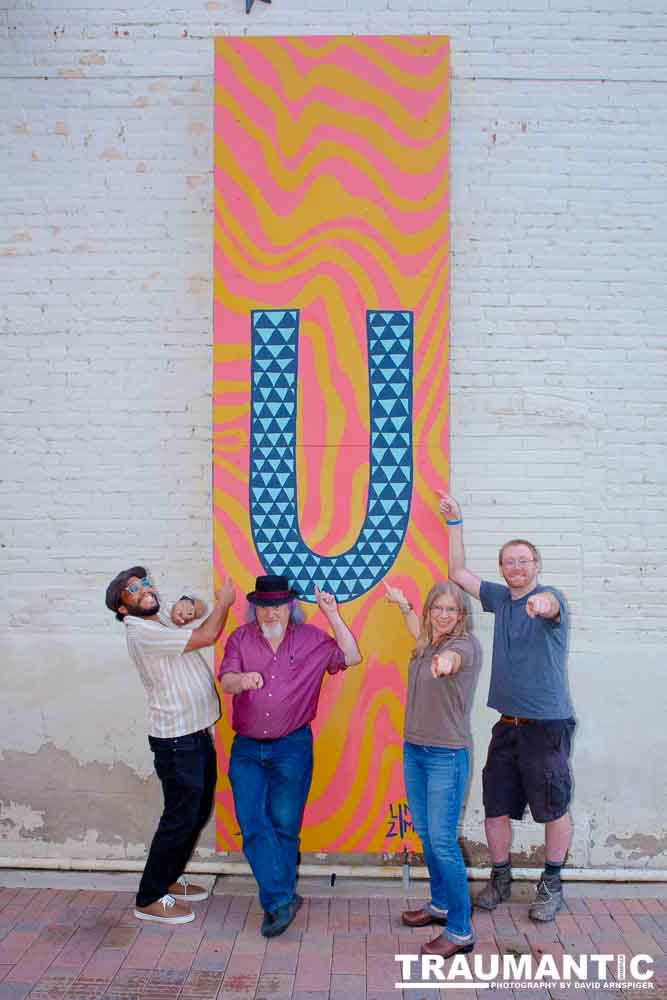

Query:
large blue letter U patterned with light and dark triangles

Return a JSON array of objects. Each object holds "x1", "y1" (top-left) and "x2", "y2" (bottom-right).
[{"x1": 250, "y1": 309, "x2": 412, "y2": 603}]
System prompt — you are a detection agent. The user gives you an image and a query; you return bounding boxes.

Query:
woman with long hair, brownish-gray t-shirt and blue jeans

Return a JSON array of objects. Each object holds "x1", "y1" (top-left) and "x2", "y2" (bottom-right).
[{"x1": 385, "y1": 582, "x2": 480, "y2": 958}]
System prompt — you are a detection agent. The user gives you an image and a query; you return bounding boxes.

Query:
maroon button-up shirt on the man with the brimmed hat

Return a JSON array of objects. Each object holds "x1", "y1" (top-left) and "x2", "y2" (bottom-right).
[{"x1": 220, "y1": 622, "x2": 345, "y2": 740}]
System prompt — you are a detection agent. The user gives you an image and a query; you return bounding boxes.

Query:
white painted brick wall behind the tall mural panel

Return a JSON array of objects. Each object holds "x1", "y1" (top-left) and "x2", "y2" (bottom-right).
[{"x1": 0, "y1": 0, "x2": 667, "y2": 867}]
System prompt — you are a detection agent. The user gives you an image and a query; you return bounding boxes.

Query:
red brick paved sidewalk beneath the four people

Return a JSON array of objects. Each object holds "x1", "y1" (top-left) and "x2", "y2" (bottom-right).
[{"x1": 0, "y1": 873, "x2": 667, "y2": 1000}]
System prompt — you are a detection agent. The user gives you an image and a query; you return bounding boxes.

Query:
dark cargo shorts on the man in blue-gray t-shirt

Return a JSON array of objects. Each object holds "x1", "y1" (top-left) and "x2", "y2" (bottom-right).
[{"x1": 482, "y1": 719, "x2": 575, "y2": 823}]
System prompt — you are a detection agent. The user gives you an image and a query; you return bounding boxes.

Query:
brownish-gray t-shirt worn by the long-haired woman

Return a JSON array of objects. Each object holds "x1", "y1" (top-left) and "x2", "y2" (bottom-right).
[{"x1": 403, "y1": 636, "x2": 481, "y2": 749}]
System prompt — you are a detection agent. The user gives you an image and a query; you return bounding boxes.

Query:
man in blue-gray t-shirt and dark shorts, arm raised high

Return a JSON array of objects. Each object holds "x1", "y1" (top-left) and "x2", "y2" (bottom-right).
[{"x1": 439, "y1": 491, "x2": 575, "y2": 921}]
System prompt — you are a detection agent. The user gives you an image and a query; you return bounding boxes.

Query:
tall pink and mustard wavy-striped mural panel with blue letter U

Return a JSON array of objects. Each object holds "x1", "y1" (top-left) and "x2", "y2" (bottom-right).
[{"x1": 213, "y1": 37, "x2": 449, "y2": 852}]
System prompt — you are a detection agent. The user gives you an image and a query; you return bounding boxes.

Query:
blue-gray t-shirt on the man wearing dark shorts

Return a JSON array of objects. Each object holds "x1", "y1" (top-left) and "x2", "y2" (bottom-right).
[{"x1": 479, "y1": 580, "x2": 572, "y2": 719}]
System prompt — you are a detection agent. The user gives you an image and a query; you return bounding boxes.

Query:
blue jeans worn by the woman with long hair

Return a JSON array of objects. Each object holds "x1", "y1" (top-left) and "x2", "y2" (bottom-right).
[{"x1": 403, "y1": 743, "x2": 473, "y2": 943}]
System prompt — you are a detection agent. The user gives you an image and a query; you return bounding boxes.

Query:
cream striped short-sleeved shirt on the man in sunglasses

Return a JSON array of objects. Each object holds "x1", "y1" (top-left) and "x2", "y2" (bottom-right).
[{"x1": 125, "y1": 612, "x2": 220, "y2": 738}]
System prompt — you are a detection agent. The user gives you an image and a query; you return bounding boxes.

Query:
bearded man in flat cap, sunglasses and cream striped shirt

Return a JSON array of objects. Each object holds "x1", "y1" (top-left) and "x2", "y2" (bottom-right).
[{"x1": 106, "y1": 566, "x2": 235, "y2": 925}]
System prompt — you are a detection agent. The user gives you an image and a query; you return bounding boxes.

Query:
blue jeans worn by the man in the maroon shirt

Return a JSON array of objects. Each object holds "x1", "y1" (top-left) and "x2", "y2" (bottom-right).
[{"x1": 229, "y1": 726, "x2": 313, "y2": 911}]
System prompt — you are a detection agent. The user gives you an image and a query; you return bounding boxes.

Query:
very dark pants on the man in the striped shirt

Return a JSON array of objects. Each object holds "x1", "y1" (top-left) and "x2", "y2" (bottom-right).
[{"x1": 137, "y1": 729, "x2": 218, "y2": 906}]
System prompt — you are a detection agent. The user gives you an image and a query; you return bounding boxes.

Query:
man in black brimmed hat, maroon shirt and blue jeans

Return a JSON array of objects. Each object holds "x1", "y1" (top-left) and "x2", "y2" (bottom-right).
[{"x1": 218, "y1": 576, "x2": 361, "y2": 937}]
